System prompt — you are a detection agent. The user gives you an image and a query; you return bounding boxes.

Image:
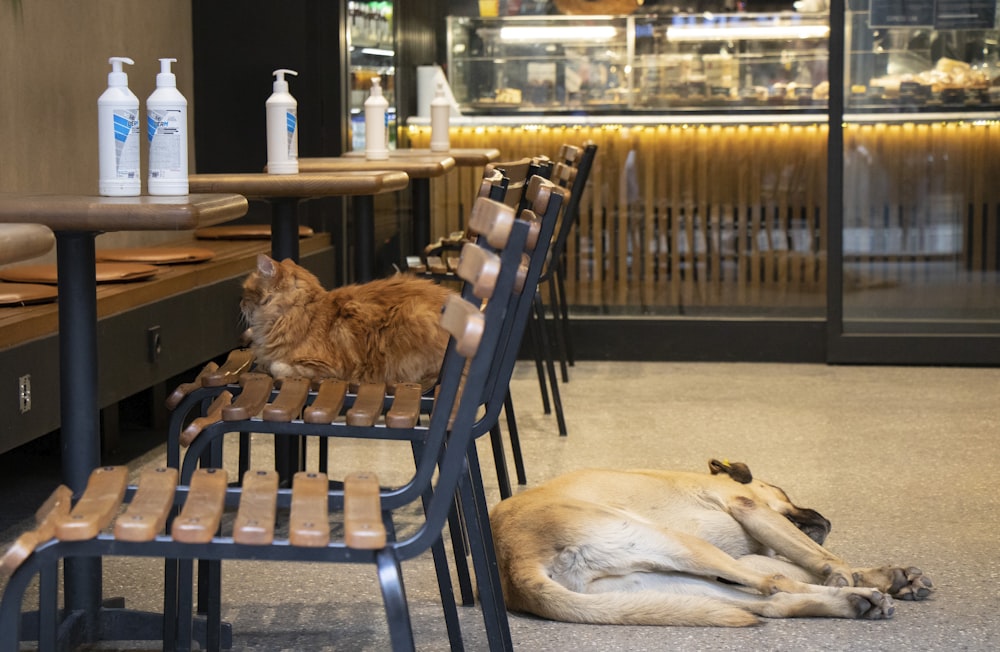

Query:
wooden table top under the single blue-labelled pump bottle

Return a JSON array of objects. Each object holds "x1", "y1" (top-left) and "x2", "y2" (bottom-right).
[{"x1": 188, "y1": 169, "x2": 410, "y2": 199}]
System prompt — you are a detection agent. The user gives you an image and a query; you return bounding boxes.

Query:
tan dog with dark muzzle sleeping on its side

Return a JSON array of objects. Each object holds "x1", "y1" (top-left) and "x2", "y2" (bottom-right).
[{"x1": 490, "y1": 460, "x2": 932, "y2": 627}]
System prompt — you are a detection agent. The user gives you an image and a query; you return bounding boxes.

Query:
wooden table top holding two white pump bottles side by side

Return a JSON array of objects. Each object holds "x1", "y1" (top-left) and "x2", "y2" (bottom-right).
[{"x1": 0, "y1": 194, "x2": 248, "y2": 231}]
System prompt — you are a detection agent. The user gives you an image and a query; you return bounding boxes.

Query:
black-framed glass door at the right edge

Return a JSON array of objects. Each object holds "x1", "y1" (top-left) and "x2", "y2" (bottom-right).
[{"x1": 828, "y1": 0, "x2": 1000, "y2": 364}]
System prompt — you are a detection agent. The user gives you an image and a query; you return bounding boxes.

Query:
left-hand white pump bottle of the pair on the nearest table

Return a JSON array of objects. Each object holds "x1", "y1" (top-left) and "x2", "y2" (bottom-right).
[{"x1": 97, "y1": 57, "x2": 142, "y2": 197}]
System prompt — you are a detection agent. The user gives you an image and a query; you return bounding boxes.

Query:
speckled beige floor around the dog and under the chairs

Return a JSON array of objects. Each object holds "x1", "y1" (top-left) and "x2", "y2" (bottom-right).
[{"x1": 0, "y1": 362, "x2": 1000, "y2": 652}]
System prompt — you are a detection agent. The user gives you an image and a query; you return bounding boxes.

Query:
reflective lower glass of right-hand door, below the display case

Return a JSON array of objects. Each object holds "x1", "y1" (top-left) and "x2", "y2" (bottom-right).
[{"x1": 844, "y1": 121, "x2": 1000, "y2": 333}]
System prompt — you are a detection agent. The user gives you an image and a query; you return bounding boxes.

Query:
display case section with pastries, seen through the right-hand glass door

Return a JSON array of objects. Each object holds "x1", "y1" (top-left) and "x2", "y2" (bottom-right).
[{"x1": 845, "y1": 0, "x2": 1000, "y2": 112}]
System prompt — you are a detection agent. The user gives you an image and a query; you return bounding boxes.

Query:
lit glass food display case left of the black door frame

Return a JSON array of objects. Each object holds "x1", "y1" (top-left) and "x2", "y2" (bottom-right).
[{"x1": 448, "y1": 12, "x2": 829, "y2": 114}]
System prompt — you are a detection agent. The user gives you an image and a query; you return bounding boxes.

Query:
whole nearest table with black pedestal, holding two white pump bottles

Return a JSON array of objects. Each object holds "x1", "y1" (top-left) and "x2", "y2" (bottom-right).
[{"x1": 0, "y1": 194, "x2": 247, "y2": 648}]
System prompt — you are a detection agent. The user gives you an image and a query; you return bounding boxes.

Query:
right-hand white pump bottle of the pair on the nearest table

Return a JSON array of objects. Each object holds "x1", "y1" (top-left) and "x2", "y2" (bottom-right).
[{"x1": 146, "y1": 59, "x2": 188, "y2": 195}]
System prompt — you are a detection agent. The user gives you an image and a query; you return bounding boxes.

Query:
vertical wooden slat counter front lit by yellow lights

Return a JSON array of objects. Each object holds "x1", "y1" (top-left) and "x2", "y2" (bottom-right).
[{"x1": 401, "y1": 123, "x2": 1000, "y2": 313}]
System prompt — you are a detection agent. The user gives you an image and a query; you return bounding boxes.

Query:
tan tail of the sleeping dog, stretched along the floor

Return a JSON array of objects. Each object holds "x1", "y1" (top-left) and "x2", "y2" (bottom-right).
[{"x1": 507, "y1": 571, "x2": 759, "y2": 627}]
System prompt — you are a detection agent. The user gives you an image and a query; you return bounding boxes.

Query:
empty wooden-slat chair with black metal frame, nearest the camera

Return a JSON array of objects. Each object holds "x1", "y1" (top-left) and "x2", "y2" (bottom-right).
[{"x1": 0, "y1": 227, "x2": 530, "y2": 652}]
